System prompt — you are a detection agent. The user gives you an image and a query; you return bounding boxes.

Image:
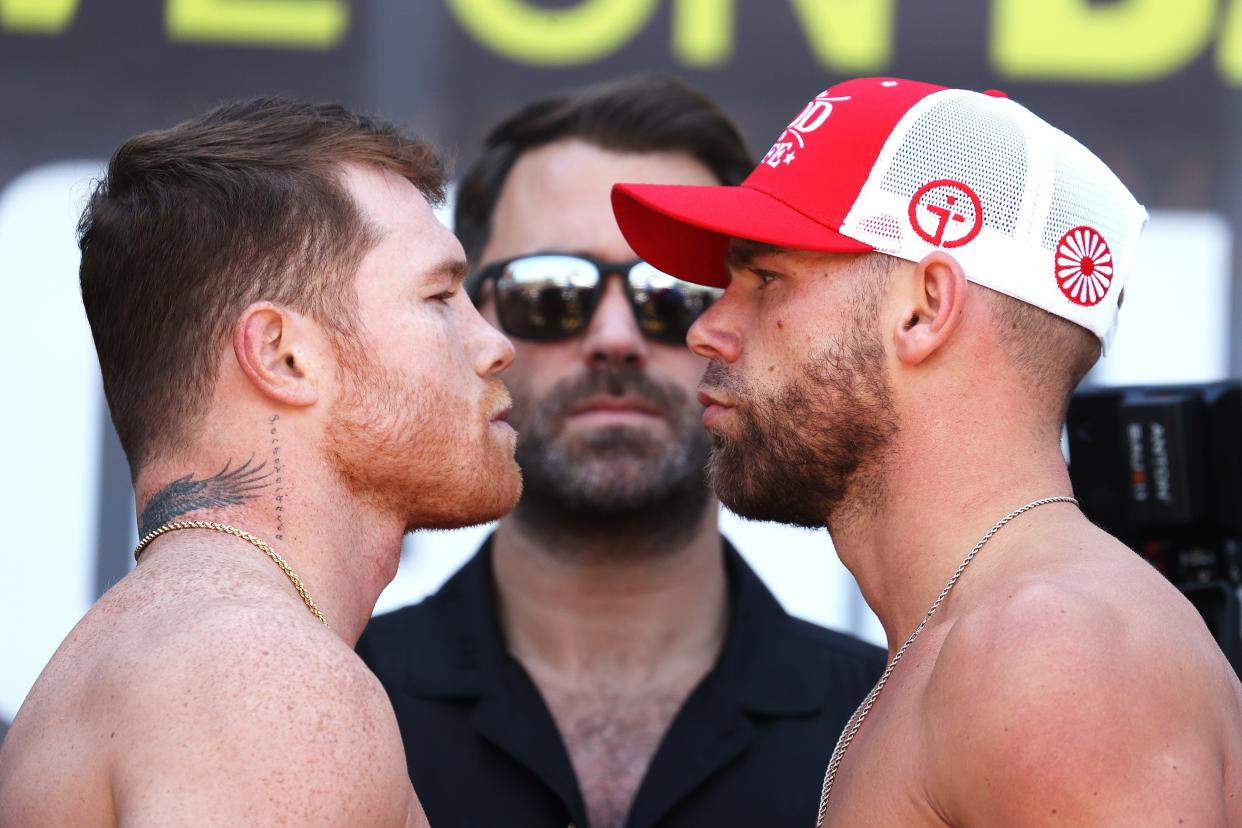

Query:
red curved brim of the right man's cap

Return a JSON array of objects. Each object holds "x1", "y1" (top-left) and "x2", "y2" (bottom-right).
[{"x1": 612, "y1": 184, "x2": 874, "y2": 288}]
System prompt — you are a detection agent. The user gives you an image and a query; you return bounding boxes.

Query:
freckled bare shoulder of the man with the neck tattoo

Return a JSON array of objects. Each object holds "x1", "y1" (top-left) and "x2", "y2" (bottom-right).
[{"x1": 113, "y1": 611, "x2": 416, "y2": 826}]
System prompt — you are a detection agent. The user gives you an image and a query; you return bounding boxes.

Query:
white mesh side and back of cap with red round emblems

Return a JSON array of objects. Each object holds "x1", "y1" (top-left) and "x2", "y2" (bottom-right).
[{"x1": 841, "y1": 89, "x2": 1146, "y2": 346}]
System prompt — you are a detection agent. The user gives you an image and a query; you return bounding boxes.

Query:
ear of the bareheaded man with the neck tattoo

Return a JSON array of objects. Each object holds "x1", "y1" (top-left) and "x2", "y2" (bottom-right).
[{"x1": 233, "y1": 302, "x2": 323, "y2": 406}]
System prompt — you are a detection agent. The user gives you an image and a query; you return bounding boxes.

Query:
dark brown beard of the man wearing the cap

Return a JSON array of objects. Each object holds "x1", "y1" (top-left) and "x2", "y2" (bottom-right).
[{"x1": 703, "y1": 299, "x2": 898, "y2": 531}]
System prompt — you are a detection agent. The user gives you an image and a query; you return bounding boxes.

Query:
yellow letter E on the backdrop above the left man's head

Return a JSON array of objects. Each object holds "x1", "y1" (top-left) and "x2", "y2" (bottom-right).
[{"x1": 164, "y1": 0, "x2": 349, "y2": 48}]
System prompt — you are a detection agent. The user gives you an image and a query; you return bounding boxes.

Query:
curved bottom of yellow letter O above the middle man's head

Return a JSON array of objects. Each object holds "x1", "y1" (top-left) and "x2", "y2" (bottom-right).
[{"x1": 448, "y1": 0, "x2": 658, "y2": 66}]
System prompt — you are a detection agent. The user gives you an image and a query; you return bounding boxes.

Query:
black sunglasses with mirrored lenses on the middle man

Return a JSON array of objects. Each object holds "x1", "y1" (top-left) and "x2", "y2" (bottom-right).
[{"x1": 468, "y1": 253, "x2": 724, "y2": 344}]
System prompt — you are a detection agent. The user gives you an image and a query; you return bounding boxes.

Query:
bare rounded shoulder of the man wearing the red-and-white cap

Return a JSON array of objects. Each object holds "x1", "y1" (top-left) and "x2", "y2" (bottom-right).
[{"x1": 923, "y1": 533, "x2": 1242, "y2": 826}]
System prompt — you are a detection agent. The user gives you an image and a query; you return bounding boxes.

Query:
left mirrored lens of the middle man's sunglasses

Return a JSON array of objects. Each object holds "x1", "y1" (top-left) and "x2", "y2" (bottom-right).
[{"x1": 496, "y1": 256, "x2": 600, "y2": 340}]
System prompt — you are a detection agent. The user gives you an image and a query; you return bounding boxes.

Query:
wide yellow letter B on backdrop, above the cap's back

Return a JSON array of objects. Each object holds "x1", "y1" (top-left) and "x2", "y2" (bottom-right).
[{"x1": 991, "y1": 0, "x2": 1216, "y2": 83}]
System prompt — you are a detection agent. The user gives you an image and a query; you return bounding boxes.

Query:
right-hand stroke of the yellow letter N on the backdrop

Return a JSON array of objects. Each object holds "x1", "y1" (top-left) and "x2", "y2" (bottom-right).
[{"x1": 794, "y1": 0, "x2": 894, "y2": 72}]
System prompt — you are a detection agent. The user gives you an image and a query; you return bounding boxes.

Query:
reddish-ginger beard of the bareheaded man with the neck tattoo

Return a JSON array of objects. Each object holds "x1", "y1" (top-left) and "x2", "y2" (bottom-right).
[{"x1": 325, "y1": 354, "x2": 522, "y2": 533}]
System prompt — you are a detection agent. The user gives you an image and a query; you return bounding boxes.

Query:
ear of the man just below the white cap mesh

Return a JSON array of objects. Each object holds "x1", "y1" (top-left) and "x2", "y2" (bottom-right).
[{"x1": 895, "y1": 251, "x2": 966, "y2": 365}]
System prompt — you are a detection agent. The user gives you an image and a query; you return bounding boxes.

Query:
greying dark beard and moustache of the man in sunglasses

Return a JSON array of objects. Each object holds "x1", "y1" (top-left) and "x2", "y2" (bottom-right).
[{"x1": 510, "y1": 366, "x2": 712, "y2": 557}]
